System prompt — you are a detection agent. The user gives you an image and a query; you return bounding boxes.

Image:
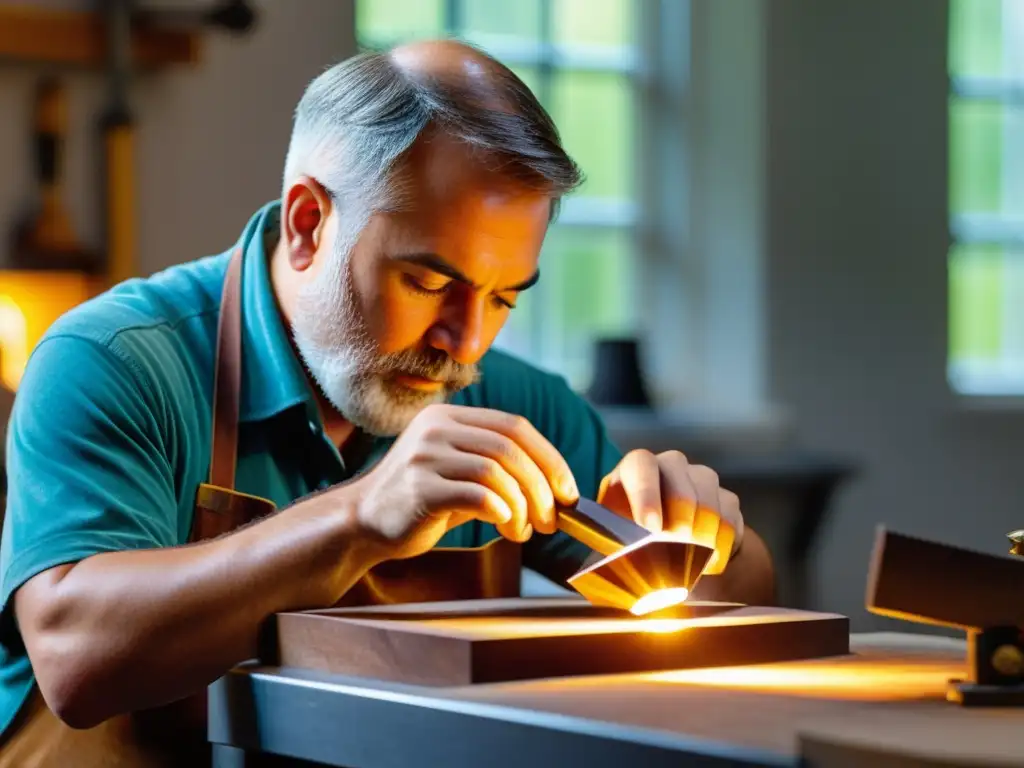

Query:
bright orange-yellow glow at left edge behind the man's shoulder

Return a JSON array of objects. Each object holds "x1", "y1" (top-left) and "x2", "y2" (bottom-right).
[{"x1": 0, "y1": 269, "x2": 94, "y2": 390}]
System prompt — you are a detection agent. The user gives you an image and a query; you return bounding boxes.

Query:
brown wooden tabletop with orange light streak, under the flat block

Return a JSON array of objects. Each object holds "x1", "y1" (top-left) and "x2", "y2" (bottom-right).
[{"x1": 209, "y1": 633, "x2": 1024, "y2": 768}]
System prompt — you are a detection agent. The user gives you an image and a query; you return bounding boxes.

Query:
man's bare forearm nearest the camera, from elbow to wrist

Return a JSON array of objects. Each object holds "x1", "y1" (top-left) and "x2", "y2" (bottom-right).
[{"x1": 15, "y1": 493, "x2": 372, "y2": 727}]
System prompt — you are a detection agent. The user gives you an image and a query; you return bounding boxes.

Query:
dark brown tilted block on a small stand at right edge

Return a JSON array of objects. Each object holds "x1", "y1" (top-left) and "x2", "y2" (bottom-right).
[{"x1": 866, "y1": 527, "x2": 1024, "y2": 630}]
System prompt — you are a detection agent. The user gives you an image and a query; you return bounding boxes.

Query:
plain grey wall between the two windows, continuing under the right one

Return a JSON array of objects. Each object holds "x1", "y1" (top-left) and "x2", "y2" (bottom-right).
[{"x1": 766, "y1": 0, "x2": 1024, "y2": 628}]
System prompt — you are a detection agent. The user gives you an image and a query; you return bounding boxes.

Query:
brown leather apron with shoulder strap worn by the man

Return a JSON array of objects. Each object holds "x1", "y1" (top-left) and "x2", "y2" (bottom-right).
[{"x1": 0, "y1": 248, "x2": 521, "y2": 768}]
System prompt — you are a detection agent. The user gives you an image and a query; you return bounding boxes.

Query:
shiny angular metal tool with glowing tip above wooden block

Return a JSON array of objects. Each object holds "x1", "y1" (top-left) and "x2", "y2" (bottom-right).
[{"x1": 557, "y1": 499, "x2": 715, "y2": 615}]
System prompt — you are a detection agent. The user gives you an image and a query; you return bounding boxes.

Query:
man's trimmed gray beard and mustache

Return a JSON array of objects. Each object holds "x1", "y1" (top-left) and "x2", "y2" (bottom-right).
[{"x1": 292, "y1": 227, "x2": 478, "y2": 436}]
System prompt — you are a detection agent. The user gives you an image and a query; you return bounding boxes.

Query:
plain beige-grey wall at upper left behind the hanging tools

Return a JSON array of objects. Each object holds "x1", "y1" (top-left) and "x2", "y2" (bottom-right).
[{"x1": 0, "y1": 0, "x2": 354, "y2": 274}]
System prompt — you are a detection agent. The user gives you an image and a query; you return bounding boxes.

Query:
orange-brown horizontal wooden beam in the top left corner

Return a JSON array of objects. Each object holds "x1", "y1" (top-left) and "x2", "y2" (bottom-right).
[{"x1": 0, "y1": 4, "x2": 200, "y2": 70}]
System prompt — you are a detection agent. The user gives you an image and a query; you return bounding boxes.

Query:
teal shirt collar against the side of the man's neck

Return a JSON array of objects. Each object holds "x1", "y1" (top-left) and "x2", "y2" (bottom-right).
[{"x1": 239, "y1": 201, "x2": 316, "y2": 421}]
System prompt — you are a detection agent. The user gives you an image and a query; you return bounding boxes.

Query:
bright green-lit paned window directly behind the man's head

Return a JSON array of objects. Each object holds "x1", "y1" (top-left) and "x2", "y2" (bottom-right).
[{"x1": 355, "y1": 0, "x2": 641, "y2": 388}]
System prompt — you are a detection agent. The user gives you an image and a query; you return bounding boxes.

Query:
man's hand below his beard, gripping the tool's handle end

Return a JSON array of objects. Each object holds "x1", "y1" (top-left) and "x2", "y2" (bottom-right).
[{"x1": 355, "y1": 404, "x2": 579, "y2": 559}]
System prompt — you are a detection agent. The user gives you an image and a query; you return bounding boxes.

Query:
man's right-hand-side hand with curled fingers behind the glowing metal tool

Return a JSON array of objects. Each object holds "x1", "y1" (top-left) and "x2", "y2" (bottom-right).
[{"x1": 597, "y1": 450, "x2": 743, "y2": 575}]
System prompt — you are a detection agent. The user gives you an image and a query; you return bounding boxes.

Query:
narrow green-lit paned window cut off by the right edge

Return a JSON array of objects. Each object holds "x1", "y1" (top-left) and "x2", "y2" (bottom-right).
[{"x1": 948, "y1": 0, "x2": 1024, "y2": 395}]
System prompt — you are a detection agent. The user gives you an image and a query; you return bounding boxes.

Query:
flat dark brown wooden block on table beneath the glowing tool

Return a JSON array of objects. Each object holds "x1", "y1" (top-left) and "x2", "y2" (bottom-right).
[{"x1": 261, "y1": 597, "x2": 849, "y2": 686}]
